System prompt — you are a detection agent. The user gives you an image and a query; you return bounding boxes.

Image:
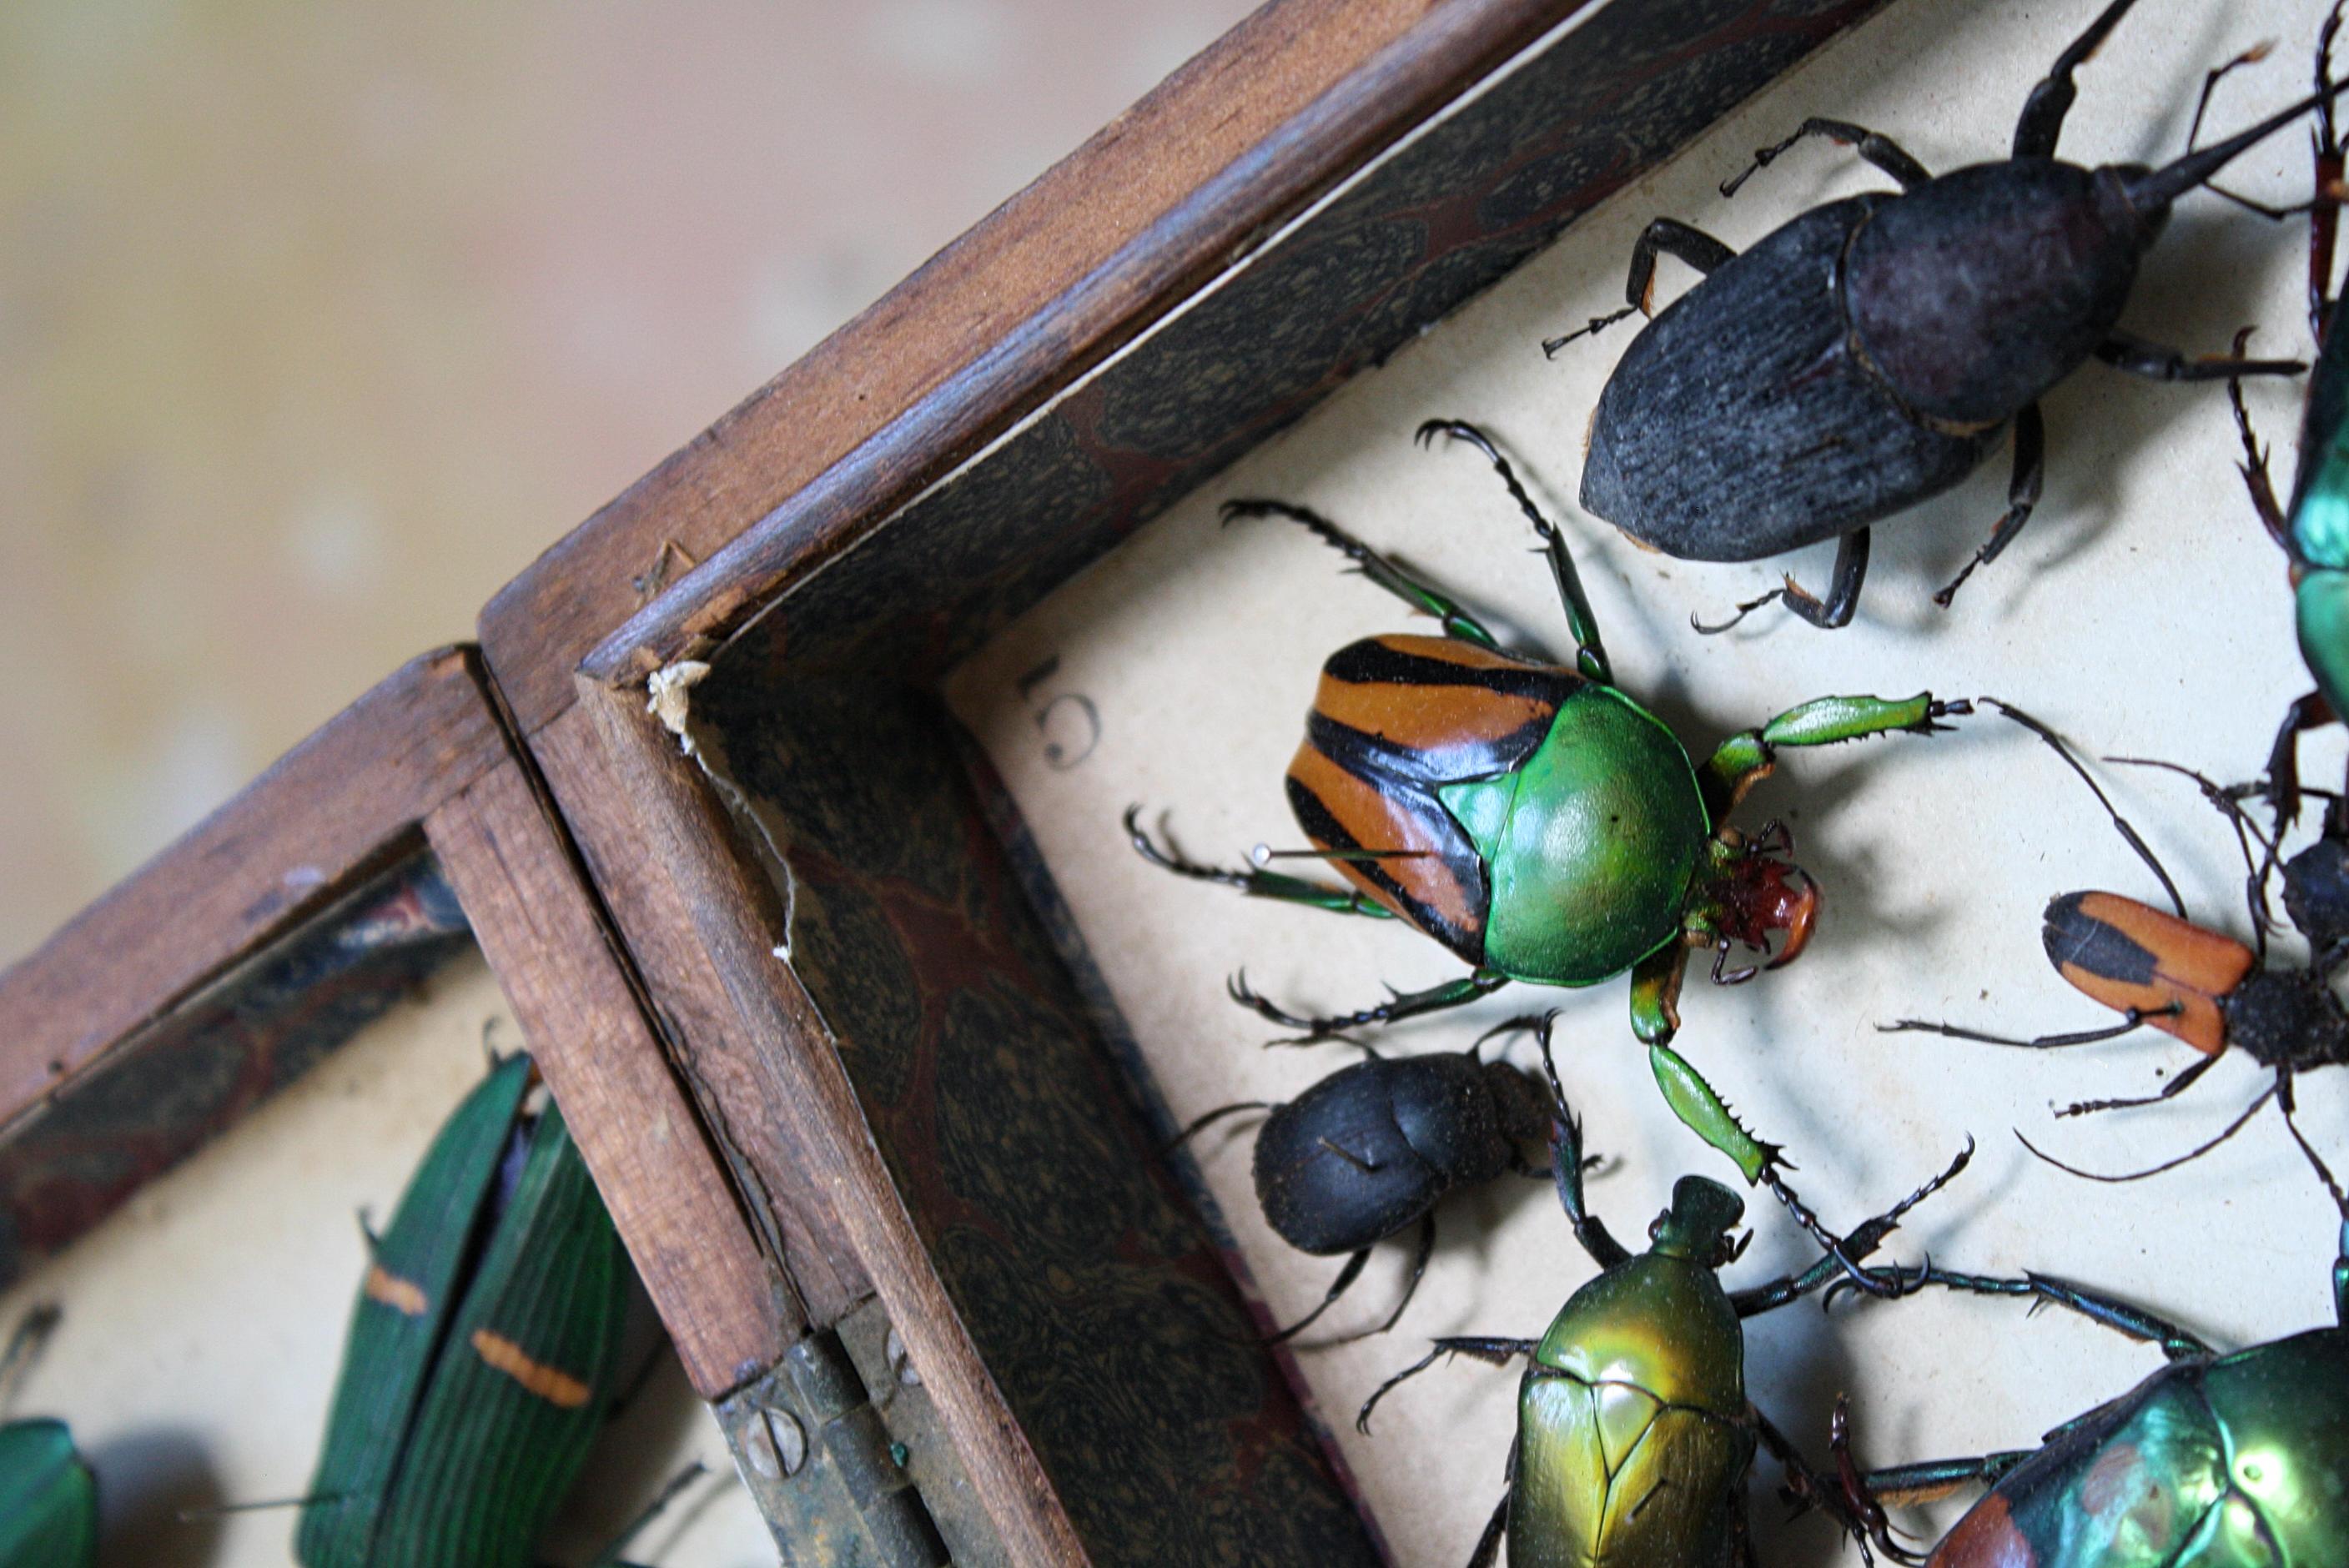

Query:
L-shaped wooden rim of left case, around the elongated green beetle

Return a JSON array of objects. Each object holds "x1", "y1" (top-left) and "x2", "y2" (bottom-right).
[{"x1": 0, "y1": 643, "x2": 806, "y2": 1399}]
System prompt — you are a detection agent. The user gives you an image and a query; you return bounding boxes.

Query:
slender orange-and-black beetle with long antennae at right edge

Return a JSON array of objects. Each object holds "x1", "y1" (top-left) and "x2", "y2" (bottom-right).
[{"x1": 1879, "y1": 701, "x2": 2349, "y2": 1181}]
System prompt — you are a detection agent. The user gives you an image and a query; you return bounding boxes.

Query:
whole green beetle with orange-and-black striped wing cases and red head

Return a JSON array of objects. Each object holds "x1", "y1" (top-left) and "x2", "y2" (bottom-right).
[{"x1": 1125, "y1": 420, "x2": 1969, "y2": 1181}]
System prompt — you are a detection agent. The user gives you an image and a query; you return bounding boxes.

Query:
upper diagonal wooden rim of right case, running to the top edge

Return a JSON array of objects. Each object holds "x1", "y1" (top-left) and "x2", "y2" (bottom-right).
[{"x1": 479, "y1": 0, "x2": 1592, "y2": 735}]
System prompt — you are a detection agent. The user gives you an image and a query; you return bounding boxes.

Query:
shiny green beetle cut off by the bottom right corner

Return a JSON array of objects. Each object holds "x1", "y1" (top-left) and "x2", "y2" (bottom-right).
[{"x1": 1846, "y1": 1207, "x2": 2349, "y2": 1568}]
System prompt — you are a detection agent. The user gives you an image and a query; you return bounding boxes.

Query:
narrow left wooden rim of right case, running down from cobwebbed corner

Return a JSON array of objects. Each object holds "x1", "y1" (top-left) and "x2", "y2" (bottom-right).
[{"x1": 556, "y1": 676, "x2": 1088, "y2": 1565}]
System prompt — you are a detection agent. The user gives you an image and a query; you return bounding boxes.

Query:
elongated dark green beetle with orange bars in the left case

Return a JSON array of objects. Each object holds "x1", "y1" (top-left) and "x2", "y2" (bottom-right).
[{"x1": 294, "y1": 1054, "x2": 627, "y2": 1568}]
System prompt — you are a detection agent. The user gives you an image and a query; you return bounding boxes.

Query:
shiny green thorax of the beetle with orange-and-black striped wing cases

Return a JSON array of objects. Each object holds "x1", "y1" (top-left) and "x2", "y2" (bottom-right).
[{"x1": 1437, "y1": 686, "x2": 1713, "y2": 986}]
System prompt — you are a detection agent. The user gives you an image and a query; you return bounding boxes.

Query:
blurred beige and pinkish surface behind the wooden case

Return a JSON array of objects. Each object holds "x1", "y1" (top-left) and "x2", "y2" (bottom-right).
[{"x1": 0, "y1": 0, "x2": 1250, "y2": 965}]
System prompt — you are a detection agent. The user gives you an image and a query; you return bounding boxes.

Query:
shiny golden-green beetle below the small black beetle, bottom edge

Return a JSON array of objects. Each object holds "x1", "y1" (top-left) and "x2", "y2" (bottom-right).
[{"x1": 1356, "y1": 1021, "x2": 1973, "y2": 1568}]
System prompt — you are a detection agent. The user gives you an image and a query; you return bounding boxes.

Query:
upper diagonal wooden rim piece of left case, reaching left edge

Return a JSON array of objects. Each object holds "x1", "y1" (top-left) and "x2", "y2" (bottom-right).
[{"x1": 0, "y1": 648, "x2": 507, "y2": 1124}]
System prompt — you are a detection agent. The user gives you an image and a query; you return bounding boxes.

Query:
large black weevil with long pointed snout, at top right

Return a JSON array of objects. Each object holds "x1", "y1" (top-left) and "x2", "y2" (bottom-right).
[{"x1": 1543, "y1": 0, "x2": 2337, "y2": 631}]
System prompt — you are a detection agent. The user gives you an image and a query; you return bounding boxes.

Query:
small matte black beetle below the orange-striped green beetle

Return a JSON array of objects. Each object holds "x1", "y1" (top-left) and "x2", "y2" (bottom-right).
[{"x1": 1177, "y1": 1023, "x2": 1551, "y2": 1343}]
